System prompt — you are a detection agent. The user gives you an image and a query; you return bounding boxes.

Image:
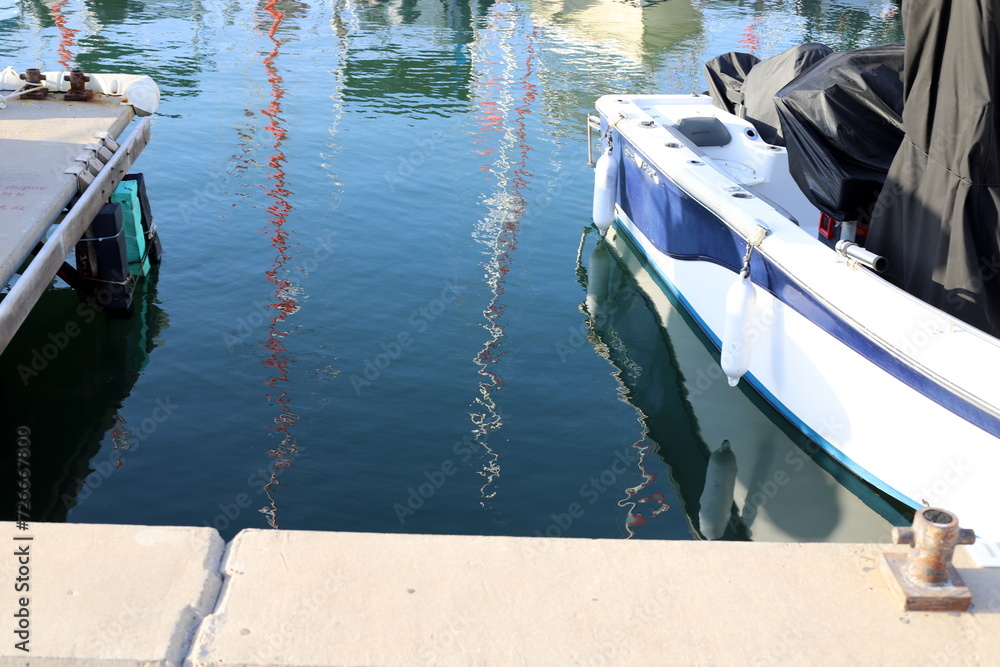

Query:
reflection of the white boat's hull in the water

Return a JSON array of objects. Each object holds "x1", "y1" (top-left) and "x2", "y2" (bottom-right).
[{"x1": 580, "y1": 229, "x2": 908, "y2": 542}]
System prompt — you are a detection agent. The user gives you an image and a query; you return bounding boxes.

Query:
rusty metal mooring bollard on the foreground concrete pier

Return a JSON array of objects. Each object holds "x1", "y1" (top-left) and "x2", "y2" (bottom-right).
[{"x1": 882, "y1": 507, "x2": 976, "y2": 611}]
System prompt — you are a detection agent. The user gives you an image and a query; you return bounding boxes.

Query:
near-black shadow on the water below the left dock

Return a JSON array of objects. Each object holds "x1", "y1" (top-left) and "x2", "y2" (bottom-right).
[{"x1": 0, "y1": 276, "x2": 170, "y2": 521}]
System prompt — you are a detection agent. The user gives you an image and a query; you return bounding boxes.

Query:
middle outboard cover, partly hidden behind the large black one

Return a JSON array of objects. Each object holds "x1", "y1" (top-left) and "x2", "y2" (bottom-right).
[{"x1": 743, "y1": 44, "x2": 833, "y2": 146}]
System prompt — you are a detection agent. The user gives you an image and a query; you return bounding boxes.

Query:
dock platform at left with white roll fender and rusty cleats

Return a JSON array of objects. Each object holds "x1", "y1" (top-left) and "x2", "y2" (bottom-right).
[{"x1": 0, "y1": 67, "x2": 159, "y2": 352}]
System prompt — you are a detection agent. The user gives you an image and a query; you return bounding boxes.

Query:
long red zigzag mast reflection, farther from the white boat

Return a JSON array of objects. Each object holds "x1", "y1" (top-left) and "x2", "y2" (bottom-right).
[{"x1": 261, "y1": 0, "x2": 299, "y2": 528}]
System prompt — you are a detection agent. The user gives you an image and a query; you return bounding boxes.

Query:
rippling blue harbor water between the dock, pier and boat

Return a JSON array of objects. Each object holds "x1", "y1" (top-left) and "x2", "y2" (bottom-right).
[{"x1": 0, "y1": 0, "x2": 901, "y2": 541}]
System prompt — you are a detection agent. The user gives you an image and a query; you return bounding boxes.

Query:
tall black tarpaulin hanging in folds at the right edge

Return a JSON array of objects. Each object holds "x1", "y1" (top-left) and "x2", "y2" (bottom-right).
[{"x1": 867, "y1": 0, "x2": 1000, "y2": 336}]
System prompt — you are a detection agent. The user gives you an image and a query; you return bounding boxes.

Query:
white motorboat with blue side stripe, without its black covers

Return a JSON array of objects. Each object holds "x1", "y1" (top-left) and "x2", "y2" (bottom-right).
[{"x1": 593, "y1": 3, "x2": 1000, "y2": 564}]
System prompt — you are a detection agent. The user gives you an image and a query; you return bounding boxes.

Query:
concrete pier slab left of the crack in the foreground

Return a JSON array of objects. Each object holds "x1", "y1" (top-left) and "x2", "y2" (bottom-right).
[{"x1": 0, "y1": 523, "x2": 226, "y2": 666}]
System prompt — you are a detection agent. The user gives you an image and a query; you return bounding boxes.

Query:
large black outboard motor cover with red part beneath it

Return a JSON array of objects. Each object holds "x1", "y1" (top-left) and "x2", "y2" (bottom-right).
[{"x1": 772, "y1": 44, "x2": 903, "y2": 220}]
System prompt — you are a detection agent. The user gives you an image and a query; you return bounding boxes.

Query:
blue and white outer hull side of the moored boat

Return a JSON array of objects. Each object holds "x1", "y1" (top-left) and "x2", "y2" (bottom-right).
[{"x1": 599, "y1": 94, "x2": 1000, "y2": 553}]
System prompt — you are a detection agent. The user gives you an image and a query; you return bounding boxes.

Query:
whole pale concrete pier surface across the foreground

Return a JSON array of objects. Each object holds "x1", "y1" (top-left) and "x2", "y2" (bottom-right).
[{"x1": 0, "y1": 523, "x2": 1000, "y2": 665}]
